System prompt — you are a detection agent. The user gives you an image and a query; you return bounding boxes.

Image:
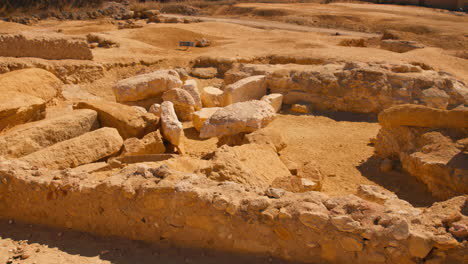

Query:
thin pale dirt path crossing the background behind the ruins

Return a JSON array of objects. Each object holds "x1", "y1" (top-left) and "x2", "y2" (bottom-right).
[{"x1": 164, "y1": 14, "x2": 380, "y2": 38}]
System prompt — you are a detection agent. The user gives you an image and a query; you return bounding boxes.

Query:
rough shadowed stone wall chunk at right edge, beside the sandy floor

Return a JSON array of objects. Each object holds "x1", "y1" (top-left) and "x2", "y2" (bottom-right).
[{"x1": 375, "y1": 105, "x2": 468, "y2": 199}]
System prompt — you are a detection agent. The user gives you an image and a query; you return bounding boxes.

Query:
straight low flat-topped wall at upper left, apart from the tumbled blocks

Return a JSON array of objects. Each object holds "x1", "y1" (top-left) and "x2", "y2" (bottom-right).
[{"x1": 0, "y1": 33, "x2": 93, "y2": 60}]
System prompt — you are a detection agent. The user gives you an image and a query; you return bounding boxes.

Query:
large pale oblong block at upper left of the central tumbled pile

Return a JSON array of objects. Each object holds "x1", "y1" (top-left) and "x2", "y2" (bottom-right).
[{"x1": 113, "y1": 70, "x2": 182, "y2": 102}]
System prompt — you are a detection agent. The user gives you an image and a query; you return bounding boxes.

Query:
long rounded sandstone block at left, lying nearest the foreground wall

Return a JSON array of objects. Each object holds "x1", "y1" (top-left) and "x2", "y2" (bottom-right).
[{"x1": 20, "y1": 127, "x2": 123, "y2": 169}]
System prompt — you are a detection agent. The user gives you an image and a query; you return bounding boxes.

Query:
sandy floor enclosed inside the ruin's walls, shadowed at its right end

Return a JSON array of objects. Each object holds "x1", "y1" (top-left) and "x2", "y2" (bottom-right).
[{"x1": 184, "y1": 111, "x2": 436, "y2": 207}]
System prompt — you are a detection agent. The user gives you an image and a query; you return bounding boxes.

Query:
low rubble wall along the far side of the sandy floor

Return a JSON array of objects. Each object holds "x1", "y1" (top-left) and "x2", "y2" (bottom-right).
[{"x1": 224, "y1": 62, "x2": 468, "y2": 114}]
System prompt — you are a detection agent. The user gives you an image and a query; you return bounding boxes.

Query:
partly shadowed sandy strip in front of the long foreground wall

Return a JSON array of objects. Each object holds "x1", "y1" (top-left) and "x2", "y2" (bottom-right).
[{"x1": 0, "y1": 220, "x2": 286, "y2": 264}]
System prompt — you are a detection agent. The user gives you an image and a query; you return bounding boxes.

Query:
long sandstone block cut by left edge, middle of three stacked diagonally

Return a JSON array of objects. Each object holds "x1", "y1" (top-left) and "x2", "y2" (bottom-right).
[{"x1": 0, "y1": 109, "x2": 99, "y2": 158}]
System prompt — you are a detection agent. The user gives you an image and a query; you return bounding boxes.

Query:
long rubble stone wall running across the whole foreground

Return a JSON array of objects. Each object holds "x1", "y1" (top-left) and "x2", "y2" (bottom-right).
[{"x1": 0, "y1": 161, "x2": 468, "y2": 263}]
